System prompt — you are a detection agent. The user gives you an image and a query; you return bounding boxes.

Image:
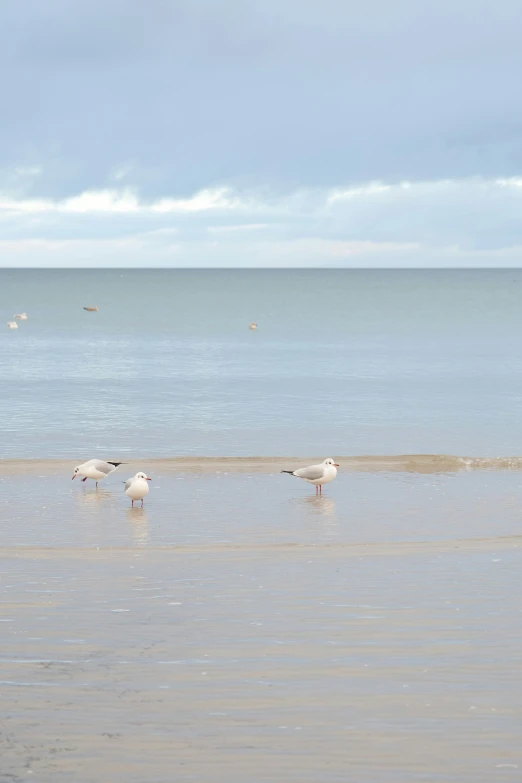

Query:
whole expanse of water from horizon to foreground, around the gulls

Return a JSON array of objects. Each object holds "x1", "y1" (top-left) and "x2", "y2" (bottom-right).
[{"x1": 0, "y1": 270, "x2": 522, "y2": 783}]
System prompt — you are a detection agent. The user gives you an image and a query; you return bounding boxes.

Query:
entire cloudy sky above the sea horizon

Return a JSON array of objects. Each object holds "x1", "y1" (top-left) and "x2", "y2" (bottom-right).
[{"x1": 0, "y1": 0, "x2": 522, "y2": 267}]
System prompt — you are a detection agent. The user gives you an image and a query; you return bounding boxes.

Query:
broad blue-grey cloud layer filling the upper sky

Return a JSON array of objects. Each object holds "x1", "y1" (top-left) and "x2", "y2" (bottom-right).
[{"x1": 0, "y1": 0, "x2": 522, "y2": 201}]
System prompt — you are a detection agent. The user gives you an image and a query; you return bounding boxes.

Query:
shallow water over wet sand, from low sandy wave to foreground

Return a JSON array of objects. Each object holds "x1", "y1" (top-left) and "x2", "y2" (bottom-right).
[{"x1": 0, "y1": 460, "x2": 522, "y2": 783}]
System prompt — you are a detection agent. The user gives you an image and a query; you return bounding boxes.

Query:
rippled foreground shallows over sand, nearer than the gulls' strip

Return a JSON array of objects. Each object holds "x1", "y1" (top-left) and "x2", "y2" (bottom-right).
[{"x1": 0, "y1": 549, "x2": 522, "y2": 783}]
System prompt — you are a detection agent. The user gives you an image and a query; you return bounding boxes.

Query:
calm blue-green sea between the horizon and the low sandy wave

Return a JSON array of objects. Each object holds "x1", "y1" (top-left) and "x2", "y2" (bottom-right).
[{"x1": 0, "y1": 270, "x2": 522, "y2": 460}]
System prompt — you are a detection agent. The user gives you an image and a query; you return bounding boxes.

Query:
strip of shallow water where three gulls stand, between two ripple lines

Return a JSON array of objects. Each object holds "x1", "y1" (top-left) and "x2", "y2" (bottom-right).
[{"x1": 0, "y1": 461, "x2": 522, "y2": 547}]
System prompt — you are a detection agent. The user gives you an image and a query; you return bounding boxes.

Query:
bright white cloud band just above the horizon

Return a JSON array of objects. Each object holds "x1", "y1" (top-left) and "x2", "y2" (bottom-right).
[{"x1": 0, "y1": 177, "x2": 522, "y2": 266}]
